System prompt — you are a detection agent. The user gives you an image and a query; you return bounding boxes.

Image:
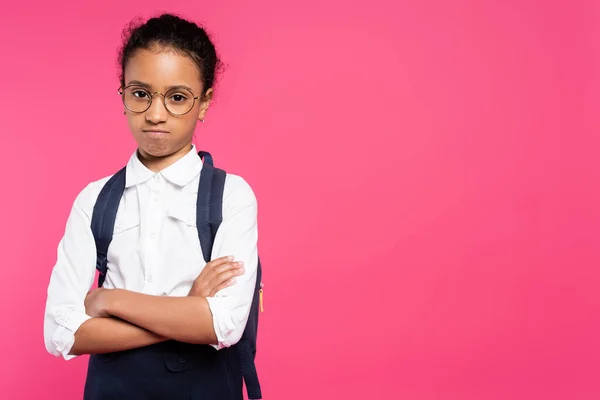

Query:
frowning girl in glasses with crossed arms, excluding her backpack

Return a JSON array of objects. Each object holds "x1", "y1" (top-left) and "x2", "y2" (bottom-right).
[{"x1": 44, "y1": 14, "x2": 258, "y2": 400}]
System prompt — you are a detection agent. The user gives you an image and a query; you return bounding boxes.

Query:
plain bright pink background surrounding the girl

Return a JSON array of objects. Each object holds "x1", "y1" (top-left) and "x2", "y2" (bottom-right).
[{"x1": 0, "y1": 0, "x2": 600, "y2": 400}]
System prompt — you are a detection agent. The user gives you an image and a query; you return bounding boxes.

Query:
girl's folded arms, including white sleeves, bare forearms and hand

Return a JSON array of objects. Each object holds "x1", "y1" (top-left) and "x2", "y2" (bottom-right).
[{"x1": 44, "y1": 177, "x2": 257, "y2": 359}]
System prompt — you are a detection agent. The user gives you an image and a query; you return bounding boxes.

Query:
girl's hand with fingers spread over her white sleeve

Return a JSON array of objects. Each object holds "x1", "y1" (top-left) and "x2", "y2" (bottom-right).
[{"x1": 188, "y1": 257, "x2": 244, "y2": 297}]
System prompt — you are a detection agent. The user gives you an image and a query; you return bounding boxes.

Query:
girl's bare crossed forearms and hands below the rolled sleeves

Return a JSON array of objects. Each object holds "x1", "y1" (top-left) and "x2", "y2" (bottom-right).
[{"x1": 69, "y1": 257, "x2": 244, "y2": 355}]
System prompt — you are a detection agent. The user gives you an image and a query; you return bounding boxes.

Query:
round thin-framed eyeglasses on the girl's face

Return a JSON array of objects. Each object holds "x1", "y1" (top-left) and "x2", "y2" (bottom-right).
[{"x1": 119, "y1": 84, "x2": 200, "y2": 116}]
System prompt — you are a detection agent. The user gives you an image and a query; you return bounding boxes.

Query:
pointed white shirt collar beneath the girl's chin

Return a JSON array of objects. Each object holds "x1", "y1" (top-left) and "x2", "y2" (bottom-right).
[{"x1": 125, "y1": 145, "x2": 202, "y2": 187}]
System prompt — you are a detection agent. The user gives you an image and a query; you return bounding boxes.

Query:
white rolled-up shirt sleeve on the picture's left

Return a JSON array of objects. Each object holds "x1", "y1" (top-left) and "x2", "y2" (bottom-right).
[{"x1": 44, "y1": 185, "x2": 97, "y2": 360}]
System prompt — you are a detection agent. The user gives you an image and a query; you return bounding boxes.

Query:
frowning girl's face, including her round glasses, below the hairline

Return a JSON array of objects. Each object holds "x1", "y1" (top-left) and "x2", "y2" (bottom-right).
[{"x1": 122, "y1": 48, "x2": 212, "y2": 158}]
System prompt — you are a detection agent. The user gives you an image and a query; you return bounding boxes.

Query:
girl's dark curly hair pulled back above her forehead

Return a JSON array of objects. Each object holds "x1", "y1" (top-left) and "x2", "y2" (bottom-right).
[{"x1": 118, "y1": 14, "x2": 222, "y2": 99}]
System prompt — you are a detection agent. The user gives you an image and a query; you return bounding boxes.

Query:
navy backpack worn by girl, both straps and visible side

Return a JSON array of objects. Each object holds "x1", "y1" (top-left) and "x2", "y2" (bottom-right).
[{"x1": 91, "y1": 151, "x2": 262, "y2": 399}]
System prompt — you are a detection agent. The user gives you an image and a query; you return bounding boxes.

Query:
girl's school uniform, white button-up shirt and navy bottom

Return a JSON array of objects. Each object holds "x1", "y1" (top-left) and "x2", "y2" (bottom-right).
[{"x1": 44, "y1": 147, "x2": 258, "y2": 400}]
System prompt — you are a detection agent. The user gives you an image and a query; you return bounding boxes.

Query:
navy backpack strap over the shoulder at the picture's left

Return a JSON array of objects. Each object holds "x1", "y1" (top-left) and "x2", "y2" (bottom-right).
[{"x1": 91, "y1": 168, "x2": 125, "y2": 287}]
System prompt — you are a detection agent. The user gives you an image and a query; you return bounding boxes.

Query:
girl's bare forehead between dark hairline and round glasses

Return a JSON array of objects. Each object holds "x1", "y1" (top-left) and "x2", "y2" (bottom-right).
[{"x1": 124, "y1": 49, "x2": 202, "y2": 91}]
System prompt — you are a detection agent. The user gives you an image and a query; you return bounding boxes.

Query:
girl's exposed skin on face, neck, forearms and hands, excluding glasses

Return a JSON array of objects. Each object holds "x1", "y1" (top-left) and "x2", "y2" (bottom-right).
[{"x1": 71, "y1": 48, "x2": 244, "y2": 354}]
